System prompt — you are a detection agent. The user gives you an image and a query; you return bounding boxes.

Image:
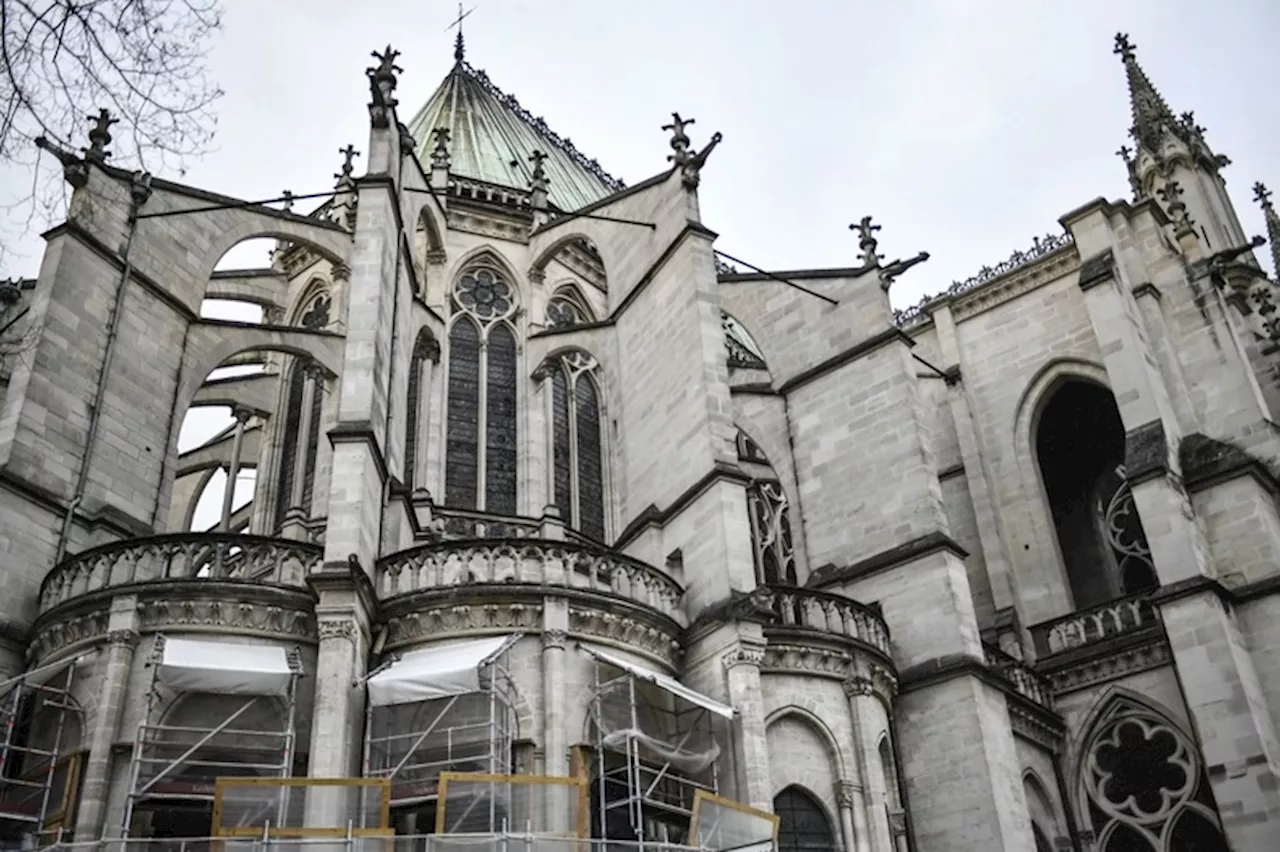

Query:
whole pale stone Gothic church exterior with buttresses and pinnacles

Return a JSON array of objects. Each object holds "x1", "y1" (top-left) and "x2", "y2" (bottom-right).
[{"x1": 0, "y1": 31, "x2": 1280, "y2": 852}]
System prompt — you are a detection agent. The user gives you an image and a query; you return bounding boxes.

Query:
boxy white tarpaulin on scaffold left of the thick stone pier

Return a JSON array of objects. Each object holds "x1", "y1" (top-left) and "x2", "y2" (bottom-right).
[{"x1": 160, "y1": 637, "x2": 293, "y2": 695}]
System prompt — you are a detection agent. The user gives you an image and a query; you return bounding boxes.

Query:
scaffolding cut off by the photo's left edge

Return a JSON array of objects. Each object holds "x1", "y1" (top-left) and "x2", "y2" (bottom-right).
[{"x1": 0, "y1": 658, "x2": 79, "y2": 843}]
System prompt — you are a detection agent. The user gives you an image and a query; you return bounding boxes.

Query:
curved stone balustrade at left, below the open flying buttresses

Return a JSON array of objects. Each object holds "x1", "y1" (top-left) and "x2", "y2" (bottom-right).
[{"x1": 40, "y1": 532, "x2": 323, "y2": 613}]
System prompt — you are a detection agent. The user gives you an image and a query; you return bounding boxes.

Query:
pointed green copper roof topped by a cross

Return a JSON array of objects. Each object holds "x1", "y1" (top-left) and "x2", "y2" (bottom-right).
[{"x1": 408, "y1": 60, "x2": 625, "y2": 211}]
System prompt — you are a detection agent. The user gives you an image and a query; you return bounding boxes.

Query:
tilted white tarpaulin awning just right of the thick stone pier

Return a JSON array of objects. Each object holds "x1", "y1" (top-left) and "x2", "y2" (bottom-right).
[{"x1": 367, "y1": 635, "x2": 520, "y2": 707}]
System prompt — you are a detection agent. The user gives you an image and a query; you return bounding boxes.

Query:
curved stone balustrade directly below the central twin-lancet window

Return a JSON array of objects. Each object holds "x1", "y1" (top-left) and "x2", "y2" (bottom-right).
[{"x1": 375, "y1": 537, "x2": 685, "y2": 624}]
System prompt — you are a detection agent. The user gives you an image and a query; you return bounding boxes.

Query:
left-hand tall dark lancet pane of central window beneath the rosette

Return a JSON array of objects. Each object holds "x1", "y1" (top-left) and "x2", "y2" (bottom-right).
[{"x1": 444, "y1": 319, "x2": 480, "y2": 509}]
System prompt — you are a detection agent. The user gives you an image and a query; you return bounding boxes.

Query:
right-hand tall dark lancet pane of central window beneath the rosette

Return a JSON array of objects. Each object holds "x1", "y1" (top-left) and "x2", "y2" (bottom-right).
[{"x1": 485, "y1": 325, "x2": 517, "y2": 514}]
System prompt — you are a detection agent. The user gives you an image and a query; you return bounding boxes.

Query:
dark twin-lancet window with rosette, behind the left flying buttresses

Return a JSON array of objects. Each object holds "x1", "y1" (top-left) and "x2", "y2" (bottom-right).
[{"x1": 275, "y1": 293, "x2": 333, "y2": 527}]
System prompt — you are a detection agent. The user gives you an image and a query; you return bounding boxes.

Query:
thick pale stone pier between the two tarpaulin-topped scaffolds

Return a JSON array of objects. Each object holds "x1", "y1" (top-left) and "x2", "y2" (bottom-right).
[{"x1": 306, "y1": 567, "x2": 375, "y2": 826}]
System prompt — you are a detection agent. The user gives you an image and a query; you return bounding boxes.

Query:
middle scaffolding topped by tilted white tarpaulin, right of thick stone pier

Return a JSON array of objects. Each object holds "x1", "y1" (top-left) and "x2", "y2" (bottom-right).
[{"x1": 364, "y1": 633, "x2": 521, "y2": 833}]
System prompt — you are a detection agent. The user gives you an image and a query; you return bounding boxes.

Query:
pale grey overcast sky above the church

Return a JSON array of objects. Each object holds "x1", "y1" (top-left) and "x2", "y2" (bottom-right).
[{"x1": 0, "y1": 0, "x2": 1280, "y2": 524}]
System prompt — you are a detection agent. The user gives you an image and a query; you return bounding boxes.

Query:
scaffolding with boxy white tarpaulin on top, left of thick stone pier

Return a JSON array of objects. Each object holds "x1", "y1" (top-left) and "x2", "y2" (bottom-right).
[{"x1": 123, "y1": 636, "x2": 303, "y2": 838}]
